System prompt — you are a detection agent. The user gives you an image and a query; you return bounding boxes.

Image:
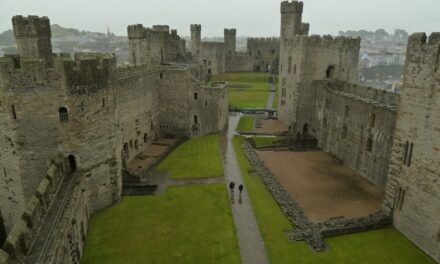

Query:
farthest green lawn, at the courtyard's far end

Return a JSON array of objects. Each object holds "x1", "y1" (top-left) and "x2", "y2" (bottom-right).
[{"x1": 210, "y1": 72, "x2": 269, "y2": 109}]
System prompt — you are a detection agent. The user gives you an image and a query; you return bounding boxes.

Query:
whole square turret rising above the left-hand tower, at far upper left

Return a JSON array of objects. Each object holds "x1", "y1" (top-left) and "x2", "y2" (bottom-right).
[{"x1": 12, "y1": 16, "x2": 52, "y2": 65}]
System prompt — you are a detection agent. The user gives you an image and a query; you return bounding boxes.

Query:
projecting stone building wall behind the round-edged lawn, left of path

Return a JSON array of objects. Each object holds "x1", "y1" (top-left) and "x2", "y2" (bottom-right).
[{"x1": 159, "y1": 67, "x2": 228, "y2": 137}]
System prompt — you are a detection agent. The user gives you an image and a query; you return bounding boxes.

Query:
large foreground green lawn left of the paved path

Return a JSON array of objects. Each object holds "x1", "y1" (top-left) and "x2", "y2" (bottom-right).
[{"x1": 82, "y1": 184, "x2": 240, "y2": 264}]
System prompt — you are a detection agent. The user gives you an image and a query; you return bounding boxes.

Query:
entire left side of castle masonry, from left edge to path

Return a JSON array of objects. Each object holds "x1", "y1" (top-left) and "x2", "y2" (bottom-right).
[{"x1": 0, "y1": 16, "x2": 228, "y2": 263}]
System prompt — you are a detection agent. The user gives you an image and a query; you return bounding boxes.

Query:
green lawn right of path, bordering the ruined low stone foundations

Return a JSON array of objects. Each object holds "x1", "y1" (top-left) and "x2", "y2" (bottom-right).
[{"x1": 234, "y1": 137, "x2": 435, "y2": 264}]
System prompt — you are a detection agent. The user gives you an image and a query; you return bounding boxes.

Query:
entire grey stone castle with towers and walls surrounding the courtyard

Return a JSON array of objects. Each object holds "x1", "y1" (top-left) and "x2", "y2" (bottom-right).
[{"x1": 0, "y1": 1, "x2": 440, "y2": 263}]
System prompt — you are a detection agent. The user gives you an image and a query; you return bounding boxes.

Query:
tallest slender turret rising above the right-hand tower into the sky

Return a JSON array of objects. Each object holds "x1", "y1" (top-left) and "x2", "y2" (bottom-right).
[{"x1": 281, "y1": 1, "x2": 308, "y2": 39}]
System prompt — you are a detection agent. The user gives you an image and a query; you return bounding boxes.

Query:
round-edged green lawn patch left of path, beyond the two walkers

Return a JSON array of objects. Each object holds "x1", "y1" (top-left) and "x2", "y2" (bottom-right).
[{"x1": 156, "y1": 135, "x2": 224, "y2": 179}]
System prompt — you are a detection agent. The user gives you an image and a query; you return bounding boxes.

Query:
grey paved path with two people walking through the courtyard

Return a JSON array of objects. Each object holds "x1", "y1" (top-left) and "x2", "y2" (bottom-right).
[{"x1": 224, "y1": 115, "x2": 269, "y2": 264}]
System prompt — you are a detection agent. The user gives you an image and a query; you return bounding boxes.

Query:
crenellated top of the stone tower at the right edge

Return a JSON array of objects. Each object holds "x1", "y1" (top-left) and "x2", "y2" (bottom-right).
[{"x1": 406, "y1": 32, "x2": 440, "y2": 65}]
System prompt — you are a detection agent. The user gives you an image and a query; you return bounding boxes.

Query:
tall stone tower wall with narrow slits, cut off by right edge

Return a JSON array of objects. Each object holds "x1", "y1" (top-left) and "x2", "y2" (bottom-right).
[{"x1": 384, "y1": 33, "x2": 440, "y2": 261}]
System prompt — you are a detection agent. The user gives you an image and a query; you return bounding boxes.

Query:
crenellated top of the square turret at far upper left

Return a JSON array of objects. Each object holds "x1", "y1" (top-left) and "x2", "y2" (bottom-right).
[{"x1": 12, "y1": 16, "x2": 51, "y2": 38}]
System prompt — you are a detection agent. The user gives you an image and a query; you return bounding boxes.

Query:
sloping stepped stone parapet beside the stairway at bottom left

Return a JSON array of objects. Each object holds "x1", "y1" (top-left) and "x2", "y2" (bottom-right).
[{"x1": 0, "y1": 157, "x2": 67, "y2": 263}]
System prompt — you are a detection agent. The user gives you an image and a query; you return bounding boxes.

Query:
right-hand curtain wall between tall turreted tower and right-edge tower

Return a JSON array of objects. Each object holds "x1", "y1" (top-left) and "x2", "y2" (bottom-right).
[{"x1": 312, "y1": 81, "x2": 398, "y2": 189}]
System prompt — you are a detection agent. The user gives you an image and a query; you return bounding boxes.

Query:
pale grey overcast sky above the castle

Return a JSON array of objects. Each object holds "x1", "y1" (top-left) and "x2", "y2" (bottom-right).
[{"x1": 0, "y1": 0, "x2": 440, "y2": 36}]
